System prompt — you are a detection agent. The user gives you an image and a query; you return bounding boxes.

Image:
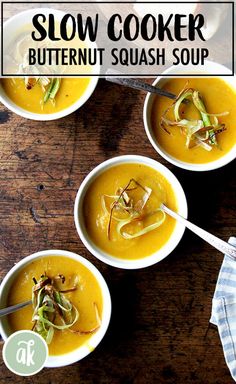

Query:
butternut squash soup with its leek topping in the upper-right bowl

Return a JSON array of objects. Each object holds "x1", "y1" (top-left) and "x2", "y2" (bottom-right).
[{"x1": 151, "y1": 78, "x2": 236, "y2": 164}]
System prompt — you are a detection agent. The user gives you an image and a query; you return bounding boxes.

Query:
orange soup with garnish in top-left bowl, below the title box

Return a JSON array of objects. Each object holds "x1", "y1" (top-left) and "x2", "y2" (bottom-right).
[{"x1": 1, "y1": 77, "x2": 90, "y2": 114}]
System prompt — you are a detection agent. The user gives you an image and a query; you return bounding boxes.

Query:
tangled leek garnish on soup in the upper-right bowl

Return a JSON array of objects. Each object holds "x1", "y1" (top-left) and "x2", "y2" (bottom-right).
[{"x1": 160, "y1": 87, "x2": 229, "y2": 151}]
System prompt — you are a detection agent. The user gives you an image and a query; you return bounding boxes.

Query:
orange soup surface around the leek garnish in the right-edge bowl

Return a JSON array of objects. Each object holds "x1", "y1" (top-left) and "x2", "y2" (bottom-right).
[{"x1": 151, "y1": 78, "x2": 236, "y2": 164}]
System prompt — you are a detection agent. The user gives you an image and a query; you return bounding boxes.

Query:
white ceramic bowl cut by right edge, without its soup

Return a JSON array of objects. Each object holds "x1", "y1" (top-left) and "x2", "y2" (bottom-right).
[{"x1": 143, "y1": 61, "x2": 236, "y2": 171}]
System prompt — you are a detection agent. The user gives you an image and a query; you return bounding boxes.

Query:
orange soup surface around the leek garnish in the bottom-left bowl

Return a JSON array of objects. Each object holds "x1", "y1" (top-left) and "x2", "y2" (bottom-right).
[{"x1": 7, "y1": 256, "x2": 103, "y2": 355}]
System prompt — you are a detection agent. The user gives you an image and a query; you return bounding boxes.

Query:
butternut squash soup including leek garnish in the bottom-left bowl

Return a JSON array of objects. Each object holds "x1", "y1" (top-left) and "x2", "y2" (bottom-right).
[{"x1": 8, "y1": 256, "x2": 103, "y2": 355}]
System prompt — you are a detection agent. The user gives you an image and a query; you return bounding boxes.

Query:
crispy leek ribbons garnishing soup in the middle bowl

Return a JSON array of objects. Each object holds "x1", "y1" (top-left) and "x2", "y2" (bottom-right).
[{"x1": 102, "y1": 179, "x2": 166, "y2": 240}]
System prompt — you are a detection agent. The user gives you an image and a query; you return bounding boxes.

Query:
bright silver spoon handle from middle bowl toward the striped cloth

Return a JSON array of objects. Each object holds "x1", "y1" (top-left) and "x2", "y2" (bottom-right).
[{"x1": 162, "y1": 204, "x2": 236, "y2": 261}]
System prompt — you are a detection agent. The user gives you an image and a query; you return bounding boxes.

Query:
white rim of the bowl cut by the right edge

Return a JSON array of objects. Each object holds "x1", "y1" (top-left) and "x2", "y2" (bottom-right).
[{"x1": 143, "y1": 60, "x2": 236, "y2": 172}]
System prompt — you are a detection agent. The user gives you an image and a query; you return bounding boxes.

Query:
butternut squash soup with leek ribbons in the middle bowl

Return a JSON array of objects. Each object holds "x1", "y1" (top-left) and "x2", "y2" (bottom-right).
[{"x1": 83, "y1": 163, "x2": 177, "y2": 260}]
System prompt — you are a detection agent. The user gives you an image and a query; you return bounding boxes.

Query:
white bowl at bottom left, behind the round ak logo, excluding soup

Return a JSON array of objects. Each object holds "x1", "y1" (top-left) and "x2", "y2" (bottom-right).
[{"x1": 0, "y1": 250, "x2": 111, "y2": 368}]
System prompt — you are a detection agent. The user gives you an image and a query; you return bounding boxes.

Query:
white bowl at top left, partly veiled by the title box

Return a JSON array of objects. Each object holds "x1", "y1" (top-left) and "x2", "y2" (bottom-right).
[{"x1": 0, "y1": 8, "x2": 100, "y2": 121}]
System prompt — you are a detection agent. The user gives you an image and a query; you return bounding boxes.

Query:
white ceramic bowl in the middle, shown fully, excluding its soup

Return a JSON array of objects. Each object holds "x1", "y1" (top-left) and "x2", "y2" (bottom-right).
[{"x1": 74, "y1": 155, "x2": 187, "y2": 269}]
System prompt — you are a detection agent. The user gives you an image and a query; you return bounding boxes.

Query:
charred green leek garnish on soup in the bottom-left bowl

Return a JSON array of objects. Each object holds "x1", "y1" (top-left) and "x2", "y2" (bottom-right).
[{"x1": 32, "y1": 274, "x2": 101, "y2": 344}]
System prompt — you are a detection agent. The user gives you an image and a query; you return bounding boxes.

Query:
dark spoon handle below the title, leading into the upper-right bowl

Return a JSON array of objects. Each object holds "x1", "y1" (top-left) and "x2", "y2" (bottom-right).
[{"x1": 106, "y1": 71, "x2": 176, "y2": 100}]
